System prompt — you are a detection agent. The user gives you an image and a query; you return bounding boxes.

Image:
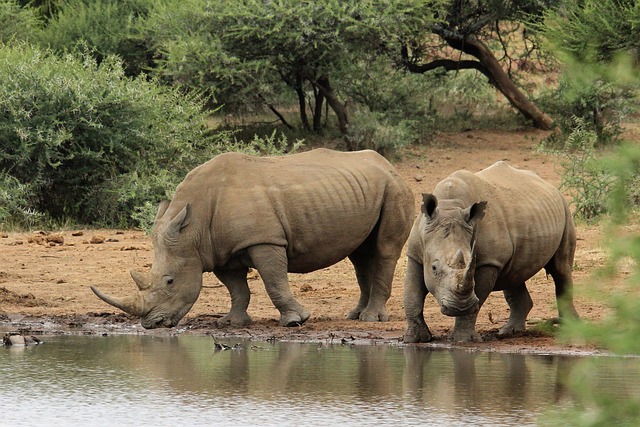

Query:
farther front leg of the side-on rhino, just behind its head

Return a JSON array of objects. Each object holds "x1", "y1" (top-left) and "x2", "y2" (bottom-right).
[{"x1": 213, "y1": 267, "x2": 252, "y2": 326}]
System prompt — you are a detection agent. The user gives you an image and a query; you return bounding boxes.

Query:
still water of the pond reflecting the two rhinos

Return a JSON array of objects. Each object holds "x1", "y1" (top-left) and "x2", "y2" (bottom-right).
[{"x1": 0, "y1": 335, "x2": 640, "y2": 426}]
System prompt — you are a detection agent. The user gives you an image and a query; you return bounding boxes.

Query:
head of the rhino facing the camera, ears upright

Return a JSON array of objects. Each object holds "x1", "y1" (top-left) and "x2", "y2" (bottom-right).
[{"x1": 422, "y1": 194, "x2": 487, "y2": 316}]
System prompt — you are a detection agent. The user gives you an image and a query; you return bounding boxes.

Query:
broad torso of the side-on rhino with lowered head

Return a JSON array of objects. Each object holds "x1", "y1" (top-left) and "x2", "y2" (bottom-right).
[{"x1": 174, "y1": 149, "x2": 413, "y2": 272}]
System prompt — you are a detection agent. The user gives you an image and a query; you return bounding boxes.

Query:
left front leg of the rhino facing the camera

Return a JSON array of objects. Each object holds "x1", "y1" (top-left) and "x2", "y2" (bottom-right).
[{"x1": 402, "y1": 258, "x2": 432, "y2": 343}]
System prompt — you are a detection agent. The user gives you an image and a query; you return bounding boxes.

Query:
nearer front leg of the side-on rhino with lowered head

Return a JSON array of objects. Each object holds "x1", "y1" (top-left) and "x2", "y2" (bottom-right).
[{"x1": 247, "y1": 245, "x2": 310, "y2": 326}]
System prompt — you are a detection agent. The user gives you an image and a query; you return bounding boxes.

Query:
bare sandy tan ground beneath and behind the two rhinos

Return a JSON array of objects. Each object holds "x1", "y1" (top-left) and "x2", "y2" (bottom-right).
[{"x1": 0, "y1": 130, "x2": 632, "y2": 352}]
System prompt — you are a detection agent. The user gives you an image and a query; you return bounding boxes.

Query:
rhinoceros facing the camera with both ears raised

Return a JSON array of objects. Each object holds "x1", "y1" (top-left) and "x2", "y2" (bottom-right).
[{"x1": 404, "y1": 162, "x2": 577, "y2": 343}]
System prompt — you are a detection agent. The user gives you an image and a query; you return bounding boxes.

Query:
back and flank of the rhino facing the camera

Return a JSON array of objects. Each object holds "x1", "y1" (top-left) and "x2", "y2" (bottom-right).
[{"x1": 436, "y1": 162, "x2": 573, "y2": 290}]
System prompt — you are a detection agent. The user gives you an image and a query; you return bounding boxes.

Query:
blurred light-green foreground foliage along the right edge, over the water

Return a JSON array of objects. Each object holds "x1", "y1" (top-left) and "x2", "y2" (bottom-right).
[{"x1": 544, "y1": 143, "x2": 640, "y2": 426}]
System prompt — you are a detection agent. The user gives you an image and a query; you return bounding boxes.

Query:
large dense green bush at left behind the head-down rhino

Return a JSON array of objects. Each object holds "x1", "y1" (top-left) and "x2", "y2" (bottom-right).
[{"x1": 0, "y1": 45, "x2": 222, "y2": 226}]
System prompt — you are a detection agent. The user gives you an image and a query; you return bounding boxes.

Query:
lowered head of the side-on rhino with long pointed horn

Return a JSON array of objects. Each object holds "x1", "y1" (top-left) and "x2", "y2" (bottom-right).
[{"x1": 91, "y1": 201, "x2": 202, "y2": 329}]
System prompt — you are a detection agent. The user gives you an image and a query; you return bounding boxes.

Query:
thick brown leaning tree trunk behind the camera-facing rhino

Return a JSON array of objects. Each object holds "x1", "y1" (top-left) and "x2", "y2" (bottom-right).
[{"x1": 445, "y1": 36, "x2": 553, "y2": 130}]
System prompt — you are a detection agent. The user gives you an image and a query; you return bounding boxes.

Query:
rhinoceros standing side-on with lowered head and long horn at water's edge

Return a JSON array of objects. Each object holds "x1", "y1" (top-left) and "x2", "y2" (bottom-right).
[{"x1": 91, "y1": 149, "x2": 415, "y2": 328}]
